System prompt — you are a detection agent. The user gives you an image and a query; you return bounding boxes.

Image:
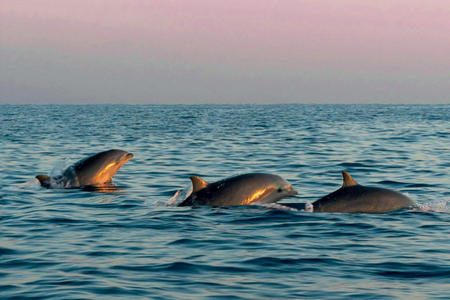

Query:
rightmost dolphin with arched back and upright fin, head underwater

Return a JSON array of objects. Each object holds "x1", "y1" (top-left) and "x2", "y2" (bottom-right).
[{"x1": 312, "y1": 171, "x2": 417, "y2": 213}]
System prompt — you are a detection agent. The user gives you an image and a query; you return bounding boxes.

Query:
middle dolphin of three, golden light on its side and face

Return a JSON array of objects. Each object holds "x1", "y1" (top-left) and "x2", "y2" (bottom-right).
[{"x1": 178, "y1": 173, "x2": 297, "y2": 206}]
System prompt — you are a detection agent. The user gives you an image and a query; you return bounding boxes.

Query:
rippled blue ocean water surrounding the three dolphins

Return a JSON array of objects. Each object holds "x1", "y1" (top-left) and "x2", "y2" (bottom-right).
[{"x1": 0, "y1": 105, "x2": 450, "y2": 299}]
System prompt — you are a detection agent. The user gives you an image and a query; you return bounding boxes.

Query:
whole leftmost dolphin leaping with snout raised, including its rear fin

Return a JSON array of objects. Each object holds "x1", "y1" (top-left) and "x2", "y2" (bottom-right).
[{"x1": 36, "y1": 149, "x2": 133, "y2": 188}]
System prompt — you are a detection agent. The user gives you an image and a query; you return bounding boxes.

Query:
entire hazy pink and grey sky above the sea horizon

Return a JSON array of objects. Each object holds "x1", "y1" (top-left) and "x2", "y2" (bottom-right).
[{"x1": 0, "y1": 0, "x2": 450, "y2": 104}]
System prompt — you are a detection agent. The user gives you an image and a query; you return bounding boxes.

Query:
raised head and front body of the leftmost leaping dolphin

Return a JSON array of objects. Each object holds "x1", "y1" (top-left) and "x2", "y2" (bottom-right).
[{"x1": 69, "y1": 149, "x2": 133, "y2": 186}]
